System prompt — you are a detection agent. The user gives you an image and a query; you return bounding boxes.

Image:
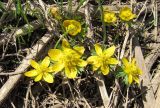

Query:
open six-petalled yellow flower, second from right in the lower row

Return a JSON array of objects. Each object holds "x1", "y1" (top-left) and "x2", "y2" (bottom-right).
[{"x1": 87, "y1": 44, "x2": 118, "y2": 75}]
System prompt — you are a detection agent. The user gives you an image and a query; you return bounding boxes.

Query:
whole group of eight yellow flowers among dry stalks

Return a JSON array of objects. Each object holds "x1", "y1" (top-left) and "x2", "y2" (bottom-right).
[{"x1": 24, "y1": 7, "x2": 142, "y2": 85}]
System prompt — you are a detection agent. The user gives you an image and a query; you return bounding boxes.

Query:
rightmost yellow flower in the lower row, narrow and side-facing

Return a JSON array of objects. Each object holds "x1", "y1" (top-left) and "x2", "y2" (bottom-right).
[{"x1": 122, "y1": 58, "x2": 142, "y2": 84}]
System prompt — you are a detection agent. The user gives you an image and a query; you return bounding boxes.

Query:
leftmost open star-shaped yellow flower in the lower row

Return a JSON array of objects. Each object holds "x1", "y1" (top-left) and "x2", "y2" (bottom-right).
[{"x1": 24, "y1": 57, "x2": 54, "y2": 83}]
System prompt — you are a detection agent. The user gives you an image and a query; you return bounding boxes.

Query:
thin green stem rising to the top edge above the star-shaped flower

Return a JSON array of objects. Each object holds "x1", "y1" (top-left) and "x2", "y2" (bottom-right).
[{"x1": 98, "y1": 0, "x2": 107, "y2": 46}]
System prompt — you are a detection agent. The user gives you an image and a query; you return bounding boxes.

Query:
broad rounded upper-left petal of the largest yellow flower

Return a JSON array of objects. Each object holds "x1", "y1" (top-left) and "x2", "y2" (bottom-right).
[{"x1": 48, "y1": 49, "x2": 63, "y2": 61}]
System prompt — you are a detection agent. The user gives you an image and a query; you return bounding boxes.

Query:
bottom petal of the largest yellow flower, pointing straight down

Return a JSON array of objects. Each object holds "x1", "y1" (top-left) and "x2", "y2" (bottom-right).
[{"x1": 65, "y1": 66, "x2": 77, "y2": 79}]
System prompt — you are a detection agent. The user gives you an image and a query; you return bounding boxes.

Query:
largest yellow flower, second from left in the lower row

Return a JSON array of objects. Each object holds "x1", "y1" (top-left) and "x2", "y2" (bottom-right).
[{"x1": 48, "y1": 39, "x2": 87, "y2": 78}]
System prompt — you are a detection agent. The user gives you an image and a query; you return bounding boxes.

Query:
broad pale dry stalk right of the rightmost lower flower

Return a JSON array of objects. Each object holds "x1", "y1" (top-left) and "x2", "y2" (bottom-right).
[{"x1": 133, "y1": 37, "x2": 155, "y2": 108}]
